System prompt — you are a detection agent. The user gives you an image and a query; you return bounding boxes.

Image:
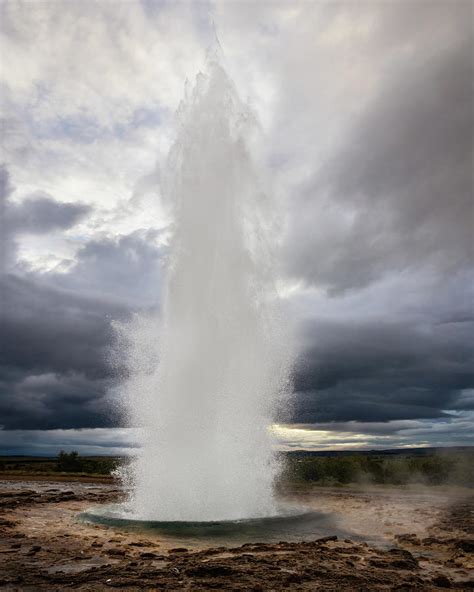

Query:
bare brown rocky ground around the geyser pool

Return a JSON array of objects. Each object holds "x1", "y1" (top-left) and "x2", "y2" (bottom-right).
[{"x1": 0, "y1": 478, "x2": 474, "y2": 592}]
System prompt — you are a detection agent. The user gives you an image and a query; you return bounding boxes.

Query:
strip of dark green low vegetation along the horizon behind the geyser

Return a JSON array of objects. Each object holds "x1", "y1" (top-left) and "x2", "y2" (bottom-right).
[{"x1": 0, "y1": 448, "x2": 474, "y2": 487}]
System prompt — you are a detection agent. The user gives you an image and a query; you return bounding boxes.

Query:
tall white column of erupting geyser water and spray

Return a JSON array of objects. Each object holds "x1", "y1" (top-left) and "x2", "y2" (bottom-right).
[{"x1": 116, "y1": 53, "x2": 289, "y2": 521}]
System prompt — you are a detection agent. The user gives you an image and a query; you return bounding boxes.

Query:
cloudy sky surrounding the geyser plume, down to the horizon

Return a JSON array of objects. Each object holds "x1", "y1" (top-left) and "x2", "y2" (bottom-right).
[{"x1": 0, "y1": 0, "x2": 474, "y2": 455}]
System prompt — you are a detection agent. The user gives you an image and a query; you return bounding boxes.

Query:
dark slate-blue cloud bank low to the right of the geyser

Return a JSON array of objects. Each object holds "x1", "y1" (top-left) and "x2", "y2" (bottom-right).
[{"x1": 287, "y1": 315, "x2": 474, "y2": 424}]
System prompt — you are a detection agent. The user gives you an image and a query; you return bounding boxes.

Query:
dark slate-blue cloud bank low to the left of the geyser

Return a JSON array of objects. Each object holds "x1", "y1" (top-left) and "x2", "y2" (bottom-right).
[{"x1": 0, "y1": 274, "x2": 129, "y2": 429}]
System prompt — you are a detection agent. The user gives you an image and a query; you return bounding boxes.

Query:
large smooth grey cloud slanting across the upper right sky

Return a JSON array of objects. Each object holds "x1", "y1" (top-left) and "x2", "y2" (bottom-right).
[{"x1": 287, "y1": 19, "x2": 474, "y2": 293}]
